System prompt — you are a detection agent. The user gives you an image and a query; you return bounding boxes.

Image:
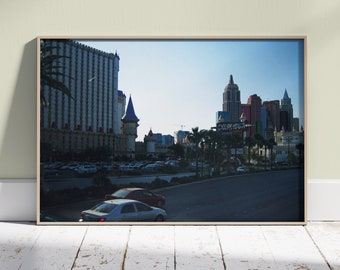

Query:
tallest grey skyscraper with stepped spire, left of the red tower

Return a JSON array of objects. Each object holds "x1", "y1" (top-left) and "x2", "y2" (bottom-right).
[{"x1": 223, "y1": 75, "x2": 241, "y2": 122}]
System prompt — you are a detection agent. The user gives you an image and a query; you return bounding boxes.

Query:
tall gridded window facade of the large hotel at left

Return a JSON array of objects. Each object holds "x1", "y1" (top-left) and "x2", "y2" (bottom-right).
[{"x1": 41, "y1": 39, "x2": 119, "y2": 132}]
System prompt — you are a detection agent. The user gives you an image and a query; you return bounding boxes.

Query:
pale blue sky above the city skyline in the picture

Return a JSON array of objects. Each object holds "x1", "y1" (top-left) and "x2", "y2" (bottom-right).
[{"x1": 81, "y1": 39, "x2": 304, "y2": 141}]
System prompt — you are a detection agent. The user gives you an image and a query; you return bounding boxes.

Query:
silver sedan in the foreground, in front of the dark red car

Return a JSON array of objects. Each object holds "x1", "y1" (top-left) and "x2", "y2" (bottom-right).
[{"x1": 79, "y1": 199, "x2": 167, "y2": 222}]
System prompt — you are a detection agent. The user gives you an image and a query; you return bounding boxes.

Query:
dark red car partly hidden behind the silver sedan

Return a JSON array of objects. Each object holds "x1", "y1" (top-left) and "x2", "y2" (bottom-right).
[{"x1": 105, "y1": 188, "x2": 165, "y2": 207}]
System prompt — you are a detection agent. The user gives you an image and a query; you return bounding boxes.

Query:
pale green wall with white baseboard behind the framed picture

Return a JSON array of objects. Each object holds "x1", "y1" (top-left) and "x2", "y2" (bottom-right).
[{"x1": 0, "y1": 0, "x2": 340, "y2": 220}]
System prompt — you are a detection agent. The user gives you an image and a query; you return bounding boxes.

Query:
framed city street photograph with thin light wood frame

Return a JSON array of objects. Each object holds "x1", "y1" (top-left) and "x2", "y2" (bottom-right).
[{"x1": 37, "y1": 36, "x2": 306, "y2": 225}]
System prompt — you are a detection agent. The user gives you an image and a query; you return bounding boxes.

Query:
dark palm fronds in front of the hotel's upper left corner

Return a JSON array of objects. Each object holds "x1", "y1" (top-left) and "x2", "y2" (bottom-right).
[{"x1": 40, "y1": 40, "x2": 73, "y2": 106}]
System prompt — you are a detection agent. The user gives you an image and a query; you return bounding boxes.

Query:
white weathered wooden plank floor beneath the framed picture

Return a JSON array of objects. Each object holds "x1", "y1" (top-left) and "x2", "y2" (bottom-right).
[{"x1": 0, "y1": 222, "x2": 340, "y2": 270}]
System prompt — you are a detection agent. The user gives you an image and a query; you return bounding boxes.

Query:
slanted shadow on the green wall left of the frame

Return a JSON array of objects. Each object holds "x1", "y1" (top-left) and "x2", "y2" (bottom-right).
[{"x1": 0, "y1": 39, "x2": 37, "y2": 179}]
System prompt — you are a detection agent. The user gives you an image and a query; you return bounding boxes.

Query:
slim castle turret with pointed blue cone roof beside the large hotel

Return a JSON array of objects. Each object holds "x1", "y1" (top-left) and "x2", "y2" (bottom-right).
[{"x1": 122, "y1": 96, "x2": 139, "y2": 159}]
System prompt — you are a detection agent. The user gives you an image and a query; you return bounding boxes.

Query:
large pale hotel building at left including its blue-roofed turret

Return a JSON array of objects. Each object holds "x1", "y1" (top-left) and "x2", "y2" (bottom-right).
[{"x1": 40, "y1": 39, "x2": 139, "y2": 161}]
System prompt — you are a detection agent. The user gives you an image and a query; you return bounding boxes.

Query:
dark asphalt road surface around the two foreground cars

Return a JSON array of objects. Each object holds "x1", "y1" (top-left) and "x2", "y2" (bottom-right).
[{"x1": 41, "y1": 169, "x2": 304, "y2": 223}]
